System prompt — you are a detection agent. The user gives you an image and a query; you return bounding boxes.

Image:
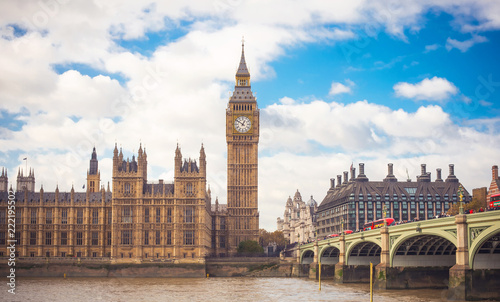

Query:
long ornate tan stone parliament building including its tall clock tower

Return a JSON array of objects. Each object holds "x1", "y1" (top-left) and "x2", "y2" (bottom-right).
[{"x1": 0, "y1": 45, "x2": 259, "y2": 263}]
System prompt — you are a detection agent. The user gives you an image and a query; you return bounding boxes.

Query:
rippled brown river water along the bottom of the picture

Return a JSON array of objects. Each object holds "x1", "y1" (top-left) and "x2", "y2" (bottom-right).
[{"x1": 8, "y1": 278, "x2": 454, "y2": 302}]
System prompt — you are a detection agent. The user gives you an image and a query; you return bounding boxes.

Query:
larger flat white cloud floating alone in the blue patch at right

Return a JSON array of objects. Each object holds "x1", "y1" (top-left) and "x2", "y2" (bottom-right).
[{"x1": 393, "y1": 76, "x2": 458, "y2": 101}]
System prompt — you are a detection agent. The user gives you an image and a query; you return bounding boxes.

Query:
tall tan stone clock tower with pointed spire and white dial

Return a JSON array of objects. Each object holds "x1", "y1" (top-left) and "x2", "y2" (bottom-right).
[{"x1": 226, "y1": 40, "x2": 259, "y2": 253}]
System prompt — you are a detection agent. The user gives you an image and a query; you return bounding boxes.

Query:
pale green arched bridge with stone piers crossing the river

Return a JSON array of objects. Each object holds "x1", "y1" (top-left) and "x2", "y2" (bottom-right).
[{"x1": 296, "y1": 211, "x2": 500, "y2": 300}]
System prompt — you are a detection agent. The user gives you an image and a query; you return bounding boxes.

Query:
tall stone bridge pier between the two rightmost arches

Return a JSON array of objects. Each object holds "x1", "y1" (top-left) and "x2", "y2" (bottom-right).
[{"x1": 448, "y1": 214, "x2": 472, "y2": 300}]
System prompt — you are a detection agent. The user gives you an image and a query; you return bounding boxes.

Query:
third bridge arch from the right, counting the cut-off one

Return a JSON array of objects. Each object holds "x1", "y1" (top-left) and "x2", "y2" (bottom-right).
[{"x1": 345, "y1": 238, "x2": 382, "y2": 265}]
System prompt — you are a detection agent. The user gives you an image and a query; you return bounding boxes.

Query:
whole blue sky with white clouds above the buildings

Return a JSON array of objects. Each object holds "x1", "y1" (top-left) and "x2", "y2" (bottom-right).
[{"x1": 0, "y1": 0, "x2": 500, "y2": 230}]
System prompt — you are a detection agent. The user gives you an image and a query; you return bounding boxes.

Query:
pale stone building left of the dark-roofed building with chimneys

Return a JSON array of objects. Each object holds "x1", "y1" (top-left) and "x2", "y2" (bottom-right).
[{"x1": 277, "y1": 190, "x2": 318, "y2": 243}]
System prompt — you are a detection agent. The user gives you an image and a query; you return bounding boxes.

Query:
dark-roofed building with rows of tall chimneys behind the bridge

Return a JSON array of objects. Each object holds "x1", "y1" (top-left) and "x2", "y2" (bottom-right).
[{"x1": 317, "y1": 163, "x2": 471, "y2": 236}]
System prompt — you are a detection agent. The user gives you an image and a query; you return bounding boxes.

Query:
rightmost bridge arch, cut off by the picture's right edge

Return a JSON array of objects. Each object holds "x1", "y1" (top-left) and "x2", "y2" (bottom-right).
[{"x1": 469, "y1": 220, "x2": 500, "y2": 269}]
